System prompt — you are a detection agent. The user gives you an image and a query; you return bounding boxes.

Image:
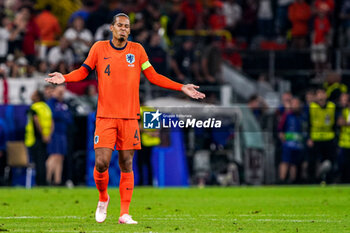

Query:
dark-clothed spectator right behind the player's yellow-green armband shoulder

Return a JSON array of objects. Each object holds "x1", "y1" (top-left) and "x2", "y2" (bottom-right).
[{"x1": 146, "y1": 33, "x2": 167, "y2": 75}]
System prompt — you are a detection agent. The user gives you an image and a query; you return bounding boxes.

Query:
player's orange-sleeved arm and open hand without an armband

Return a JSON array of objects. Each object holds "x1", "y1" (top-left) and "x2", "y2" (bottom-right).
[{"x1": 45, "y1": 64, "x2": 89, "y2": 84}]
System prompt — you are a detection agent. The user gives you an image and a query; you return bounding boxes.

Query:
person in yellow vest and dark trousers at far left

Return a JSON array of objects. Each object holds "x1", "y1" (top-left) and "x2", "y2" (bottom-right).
[{"x1": 24, "y1": 90, "x2": 53, "y2": 186}]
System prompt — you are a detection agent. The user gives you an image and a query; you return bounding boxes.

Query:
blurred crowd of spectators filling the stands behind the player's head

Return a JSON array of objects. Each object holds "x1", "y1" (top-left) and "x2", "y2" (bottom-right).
[{"x1": 0, "y1": 0, "x2": 350, "y2": 85}]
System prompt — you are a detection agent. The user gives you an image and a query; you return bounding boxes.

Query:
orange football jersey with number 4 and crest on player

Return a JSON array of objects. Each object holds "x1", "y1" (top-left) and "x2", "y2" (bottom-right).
[{"x1": 83, "y1": 41, "x2": 150, "y2": 119}]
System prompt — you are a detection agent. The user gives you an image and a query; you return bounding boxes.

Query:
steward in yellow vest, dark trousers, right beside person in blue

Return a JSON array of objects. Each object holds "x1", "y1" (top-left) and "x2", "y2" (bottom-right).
[{"x1": 307, "y1": 88, "x2": 336, "y2": 182}]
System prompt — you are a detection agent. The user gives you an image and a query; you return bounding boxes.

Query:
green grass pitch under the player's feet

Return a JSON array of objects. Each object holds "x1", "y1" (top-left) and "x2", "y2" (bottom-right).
[{"x1": 0, "y1": 186, "x2": 350, "y2": 232}]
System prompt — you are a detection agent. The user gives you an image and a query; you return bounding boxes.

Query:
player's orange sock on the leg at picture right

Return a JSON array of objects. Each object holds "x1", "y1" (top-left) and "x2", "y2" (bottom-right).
[{"x1": 119, "y1": 172, "x2": 134, "y2": 216}]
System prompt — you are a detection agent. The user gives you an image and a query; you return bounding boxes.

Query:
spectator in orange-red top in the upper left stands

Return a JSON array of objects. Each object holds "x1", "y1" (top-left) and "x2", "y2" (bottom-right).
[{"x1": 35, "y1": 5, "x2": 61, "y2": 43}]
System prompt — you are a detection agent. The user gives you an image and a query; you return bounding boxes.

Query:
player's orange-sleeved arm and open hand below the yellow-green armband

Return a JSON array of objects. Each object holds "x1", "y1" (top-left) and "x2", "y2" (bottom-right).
[{"x1": 143, "y1": 66, "x2": 205, "y2": 99}]
